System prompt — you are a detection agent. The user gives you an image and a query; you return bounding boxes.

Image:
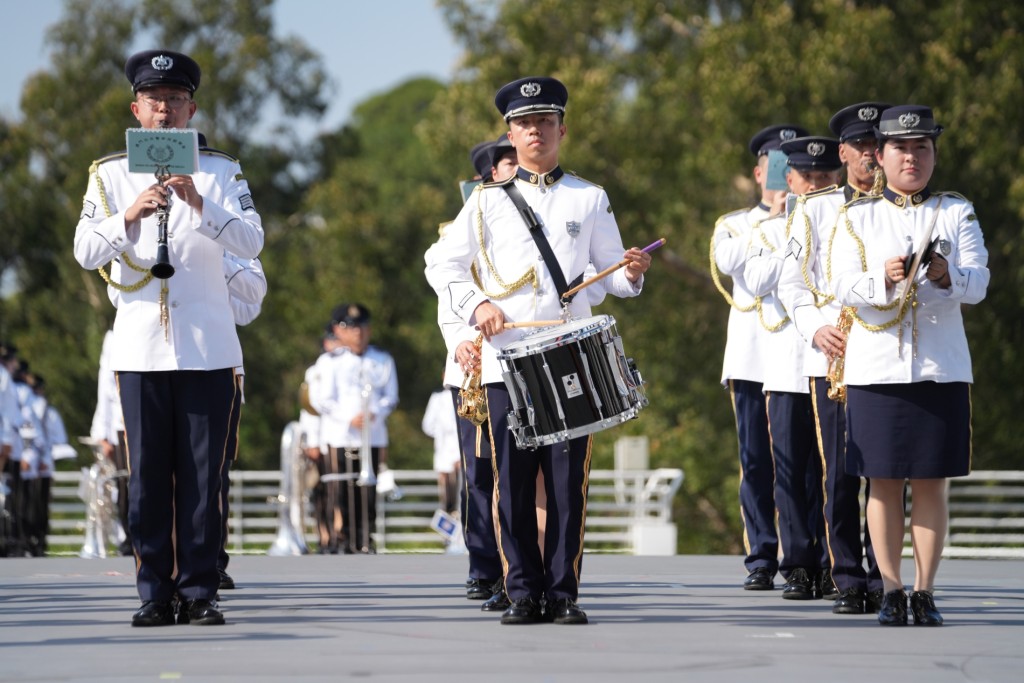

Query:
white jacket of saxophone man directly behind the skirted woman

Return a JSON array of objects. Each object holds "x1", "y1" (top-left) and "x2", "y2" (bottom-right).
[{"x1": 778, "y1": 187, "x2": 846, "y2": 377}]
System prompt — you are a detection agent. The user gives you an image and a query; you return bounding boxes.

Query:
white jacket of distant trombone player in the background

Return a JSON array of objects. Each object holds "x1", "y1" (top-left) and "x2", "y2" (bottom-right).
[{"x1": 309, "y1": 346, "x2": 398, "y2": 449}]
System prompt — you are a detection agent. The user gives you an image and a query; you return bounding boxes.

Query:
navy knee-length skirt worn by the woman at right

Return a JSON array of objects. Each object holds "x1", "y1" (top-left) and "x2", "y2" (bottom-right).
[{"x1": 846, "y1": 382, "x2": 971, "y2": 479}]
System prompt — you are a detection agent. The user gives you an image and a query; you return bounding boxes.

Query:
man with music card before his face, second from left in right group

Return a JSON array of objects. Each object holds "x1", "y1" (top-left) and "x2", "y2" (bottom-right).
[{"x1": 743, "y1": 136, "x2": 842, "y2": 600}]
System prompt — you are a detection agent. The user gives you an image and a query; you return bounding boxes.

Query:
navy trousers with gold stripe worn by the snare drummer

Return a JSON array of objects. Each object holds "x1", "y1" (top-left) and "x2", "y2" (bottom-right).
[{"x1": 484, "y1": 384, "x2": 592, "y2": 600}]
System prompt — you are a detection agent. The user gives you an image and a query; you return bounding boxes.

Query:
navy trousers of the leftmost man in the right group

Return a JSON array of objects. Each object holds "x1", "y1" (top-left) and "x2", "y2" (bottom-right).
[{"x1": 729, "y1": 380, "x2": 778, "y2": 574}]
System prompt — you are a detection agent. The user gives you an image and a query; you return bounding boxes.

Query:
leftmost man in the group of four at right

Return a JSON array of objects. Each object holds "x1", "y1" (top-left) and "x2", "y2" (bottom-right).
[{"x1": 711, "y1": 124, "x2": 807, "y2": 591}]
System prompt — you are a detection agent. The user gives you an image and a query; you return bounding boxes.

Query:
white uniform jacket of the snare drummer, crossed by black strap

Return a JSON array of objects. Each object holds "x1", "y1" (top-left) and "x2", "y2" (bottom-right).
[{"x1": 425, "y1": 175, "x2": 643, "y2": 383}]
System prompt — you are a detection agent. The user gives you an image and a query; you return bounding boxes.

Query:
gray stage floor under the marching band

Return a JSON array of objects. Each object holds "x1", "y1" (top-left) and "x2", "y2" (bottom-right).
[{"x1": 0, "y1": 555, "x2": 1024, "y2": 683}]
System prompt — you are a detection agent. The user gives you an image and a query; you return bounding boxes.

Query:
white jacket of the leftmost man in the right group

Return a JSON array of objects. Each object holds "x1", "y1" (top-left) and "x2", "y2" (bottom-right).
[{"x1": 712, "y1": 205, "x2": 768, "y2": 385}]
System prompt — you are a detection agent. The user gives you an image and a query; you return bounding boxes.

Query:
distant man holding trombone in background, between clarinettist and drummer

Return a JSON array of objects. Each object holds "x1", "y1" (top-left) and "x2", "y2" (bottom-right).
[{"x1": 309, "y1": 303, "x2": 398, "y2": 554}]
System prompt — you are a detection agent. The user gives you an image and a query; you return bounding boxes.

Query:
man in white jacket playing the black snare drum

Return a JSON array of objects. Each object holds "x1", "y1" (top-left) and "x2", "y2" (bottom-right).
[{"x1": 426, "y1": 77, "x2": 650, "y2": 624}]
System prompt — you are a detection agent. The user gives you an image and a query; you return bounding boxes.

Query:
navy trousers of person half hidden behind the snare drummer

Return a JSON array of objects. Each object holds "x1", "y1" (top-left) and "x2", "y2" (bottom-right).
[{"x1": 452, "y1": 389, "x2": 504, "y2": 582}]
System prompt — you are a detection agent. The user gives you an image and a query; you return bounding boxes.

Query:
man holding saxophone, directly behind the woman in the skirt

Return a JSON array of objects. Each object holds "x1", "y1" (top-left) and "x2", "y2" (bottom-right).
[{"x1": 778, "y1": 101, "x2": 889, "y2": 614}]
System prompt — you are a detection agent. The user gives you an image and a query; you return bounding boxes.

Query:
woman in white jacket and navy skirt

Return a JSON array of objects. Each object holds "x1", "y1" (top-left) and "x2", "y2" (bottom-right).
[{"x1": 831, "y1": 104, "x2": 989, "y2": 626}]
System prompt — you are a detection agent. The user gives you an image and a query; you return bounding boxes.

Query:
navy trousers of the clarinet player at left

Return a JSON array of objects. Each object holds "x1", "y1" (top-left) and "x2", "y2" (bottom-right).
[{"x1": 117, "y1": 368, "x2": 237, "y2": 601}]
